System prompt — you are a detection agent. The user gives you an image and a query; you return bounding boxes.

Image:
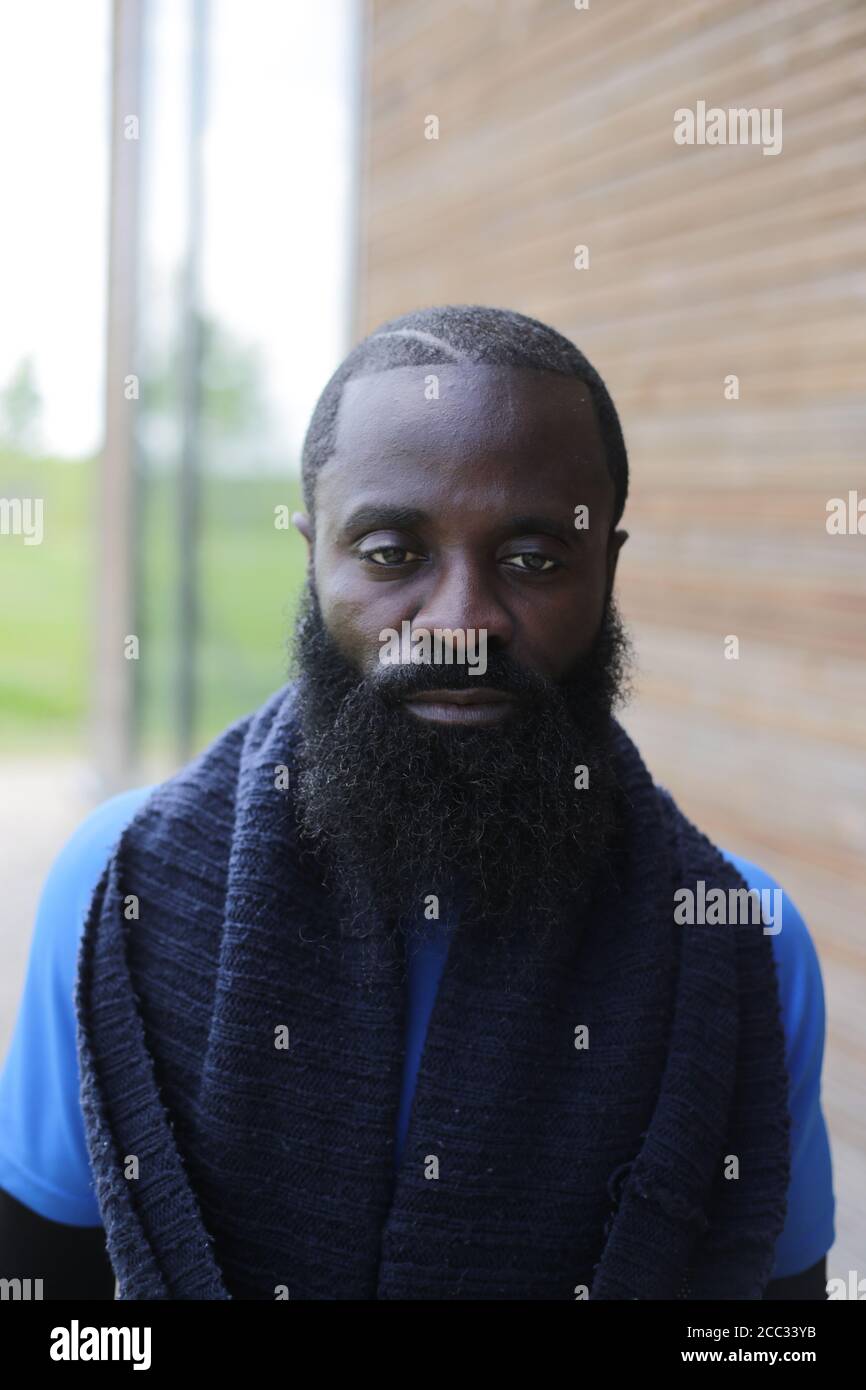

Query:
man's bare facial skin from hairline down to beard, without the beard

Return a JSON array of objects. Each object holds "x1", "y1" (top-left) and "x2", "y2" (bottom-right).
[{"x1": 297, "y1": 364, "x2": 626, "y2": 700}]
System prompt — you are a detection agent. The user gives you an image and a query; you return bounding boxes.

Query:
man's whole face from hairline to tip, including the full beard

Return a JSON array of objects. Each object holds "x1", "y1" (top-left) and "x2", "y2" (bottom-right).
[{"x1": 295, "y1": 366, "x2": 628, "y2": 961}]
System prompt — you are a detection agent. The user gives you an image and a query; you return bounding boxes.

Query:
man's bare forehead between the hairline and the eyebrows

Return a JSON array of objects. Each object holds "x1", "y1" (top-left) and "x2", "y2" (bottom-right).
[{"x1": 335, "y1": 363, "x2": 603, "y2": 459}]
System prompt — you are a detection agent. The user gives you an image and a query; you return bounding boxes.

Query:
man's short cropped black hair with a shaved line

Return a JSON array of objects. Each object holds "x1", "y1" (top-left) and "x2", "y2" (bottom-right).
[{"x1": 300, "y1": 304, "x2": 628, "y2": 525}]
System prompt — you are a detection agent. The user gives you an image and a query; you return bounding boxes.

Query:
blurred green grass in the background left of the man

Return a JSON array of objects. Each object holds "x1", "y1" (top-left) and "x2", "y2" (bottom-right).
[{"x1": 0, "y1": 455, "x2": 306, "y2": 752}]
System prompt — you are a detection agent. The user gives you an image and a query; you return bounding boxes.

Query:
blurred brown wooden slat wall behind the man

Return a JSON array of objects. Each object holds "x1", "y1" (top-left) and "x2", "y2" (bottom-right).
[{"x1": 356, "y1": 0, "x2": 866, "y2": 1273}]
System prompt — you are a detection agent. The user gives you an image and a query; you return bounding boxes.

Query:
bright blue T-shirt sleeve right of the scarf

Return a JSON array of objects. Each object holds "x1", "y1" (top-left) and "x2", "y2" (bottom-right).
[{"x1": 726, "y1": 852, "x2": 835, "y2": 1279}]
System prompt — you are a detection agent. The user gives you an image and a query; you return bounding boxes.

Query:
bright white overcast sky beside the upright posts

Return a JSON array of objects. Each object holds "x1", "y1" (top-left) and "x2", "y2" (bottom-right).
[{"x1": 0, "y1": 0, "x2": 357, "y2": 467}]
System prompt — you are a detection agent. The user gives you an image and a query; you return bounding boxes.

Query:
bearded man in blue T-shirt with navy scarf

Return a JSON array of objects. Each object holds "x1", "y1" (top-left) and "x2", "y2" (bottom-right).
[{"x1": 0, "y1": 306, "x2": 834, "y2": 1300}]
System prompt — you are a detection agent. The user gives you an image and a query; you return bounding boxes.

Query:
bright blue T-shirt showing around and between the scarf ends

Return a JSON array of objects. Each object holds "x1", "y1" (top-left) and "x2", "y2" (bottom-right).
[{"x1": 0, "y1": 787, "x2": 835, "y2": 1279}]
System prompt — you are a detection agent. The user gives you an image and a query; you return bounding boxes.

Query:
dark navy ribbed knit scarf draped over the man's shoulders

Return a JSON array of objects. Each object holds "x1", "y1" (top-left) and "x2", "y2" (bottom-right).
[{"x1": 75, "y1": 687, "x2": 790, "y2": 1300}]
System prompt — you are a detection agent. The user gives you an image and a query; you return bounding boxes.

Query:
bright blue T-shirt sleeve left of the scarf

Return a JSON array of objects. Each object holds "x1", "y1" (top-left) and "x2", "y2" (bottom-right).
[{"x1": 0, "y1": 788, "x2": 150, "y2": 1226}]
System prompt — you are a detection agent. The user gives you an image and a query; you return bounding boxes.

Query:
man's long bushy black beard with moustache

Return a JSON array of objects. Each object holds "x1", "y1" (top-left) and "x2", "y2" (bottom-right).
[{"x1": 287, "y1": 587, "x2": 631, "y2": 967}]
